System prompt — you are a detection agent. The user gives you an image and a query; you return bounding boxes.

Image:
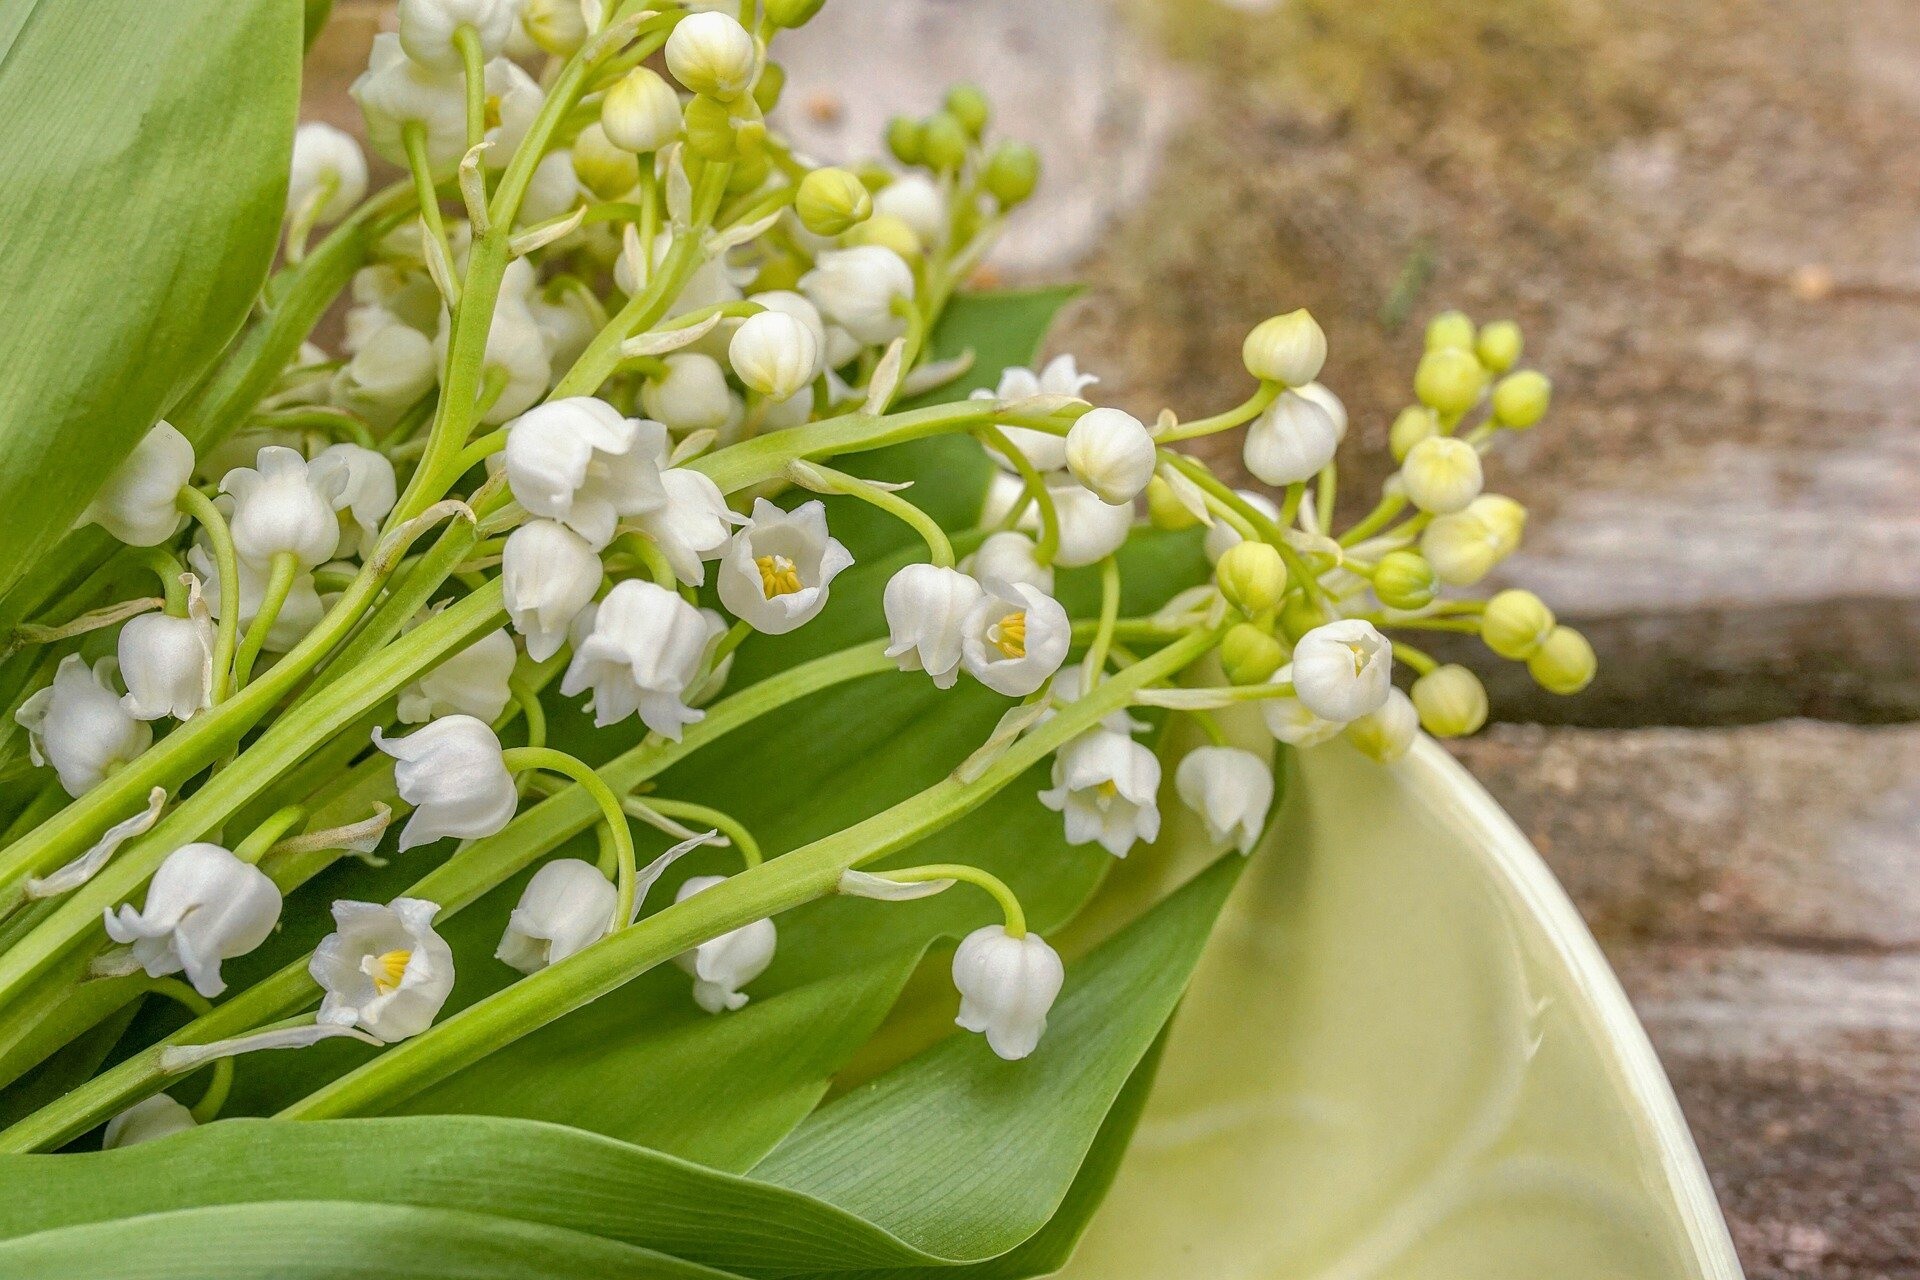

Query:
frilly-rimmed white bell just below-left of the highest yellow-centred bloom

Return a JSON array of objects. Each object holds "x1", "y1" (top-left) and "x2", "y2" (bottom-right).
[{"x1": 561, "y1": 578, "x2": 722, "y2": 743}]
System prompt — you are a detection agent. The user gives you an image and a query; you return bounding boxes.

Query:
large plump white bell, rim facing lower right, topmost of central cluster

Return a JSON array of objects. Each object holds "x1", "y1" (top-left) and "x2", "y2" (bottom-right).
[{"x1": 505, "y1": 395, "x2": 666, "y2": 551}]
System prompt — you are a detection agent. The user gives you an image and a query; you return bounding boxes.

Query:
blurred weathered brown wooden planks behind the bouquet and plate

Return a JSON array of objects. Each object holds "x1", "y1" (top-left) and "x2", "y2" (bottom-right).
[{"x1": 307, "y1": 0, "x2": 1920, "y2": 1280}]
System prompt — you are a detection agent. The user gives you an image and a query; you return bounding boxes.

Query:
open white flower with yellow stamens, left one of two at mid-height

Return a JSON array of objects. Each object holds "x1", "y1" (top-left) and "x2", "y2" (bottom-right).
[{"x1": 720, "y1": 497, "x2": 852, "y2": 635}]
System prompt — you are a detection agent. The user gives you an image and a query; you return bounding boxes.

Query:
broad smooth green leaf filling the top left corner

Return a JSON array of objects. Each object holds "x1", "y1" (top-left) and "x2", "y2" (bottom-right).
[{"x1": 0, "y1": 0, "x2": 301, "y2": 614}]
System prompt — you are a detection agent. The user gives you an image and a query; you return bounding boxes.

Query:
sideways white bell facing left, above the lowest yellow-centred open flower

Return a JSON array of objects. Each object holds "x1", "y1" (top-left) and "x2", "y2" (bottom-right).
[{"x1": 372, "y1": 716, "x2": 520, "y2": 852}]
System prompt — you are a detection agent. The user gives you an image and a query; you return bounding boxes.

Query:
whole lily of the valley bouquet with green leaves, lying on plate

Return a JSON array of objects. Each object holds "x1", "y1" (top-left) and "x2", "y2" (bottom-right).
[{"x1": 0, "y1": 0, "x2": 1594, "y2": 1276}]
